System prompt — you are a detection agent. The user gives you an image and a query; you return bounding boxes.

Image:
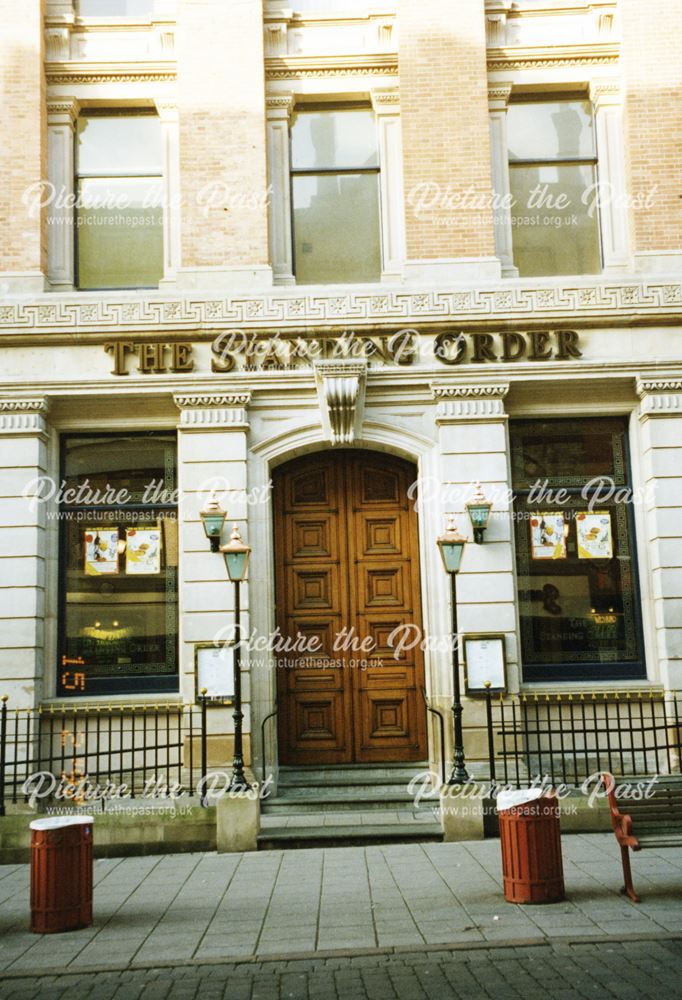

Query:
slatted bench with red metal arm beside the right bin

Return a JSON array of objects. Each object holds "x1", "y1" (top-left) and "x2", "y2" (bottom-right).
[{"x1": 602, "y1": 771, "x2": 682, "y2": 903}]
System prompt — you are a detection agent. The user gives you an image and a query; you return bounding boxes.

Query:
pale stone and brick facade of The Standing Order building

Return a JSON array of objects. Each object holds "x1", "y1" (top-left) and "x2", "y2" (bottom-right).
[{"x1": 0, "y1": 0, "x2": 682, "y2": 772}]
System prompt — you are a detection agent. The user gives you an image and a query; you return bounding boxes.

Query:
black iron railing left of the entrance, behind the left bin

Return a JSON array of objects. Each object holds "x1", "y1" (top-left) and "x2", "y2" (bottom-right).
[{"x1": 0, "y1": 698, "x2": 207, "y2": 816}]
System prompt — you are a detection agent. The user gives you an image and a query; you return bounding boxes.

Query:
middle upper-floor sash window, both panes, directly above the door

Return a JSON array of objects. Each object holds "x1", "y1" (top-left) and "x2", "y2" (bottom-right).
[{"x1": 291, "y1": 108, "x2": 381, "y2": 284}]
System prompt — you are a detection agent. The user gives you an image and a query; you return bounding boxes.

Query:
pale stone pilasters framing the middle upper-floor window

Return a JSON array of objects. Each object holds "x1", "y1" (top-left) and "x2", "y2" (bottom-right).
[{"x1": 265, "y1": 87, "x2": 405, "y2": 285}]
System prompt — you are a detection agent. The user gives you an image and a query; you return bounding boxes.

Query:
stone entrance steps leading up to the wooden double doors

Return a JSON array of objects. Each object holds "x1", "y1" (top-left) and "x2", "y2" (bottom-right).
[{"x1": 258, "y1": 763, "x2": 443, "y2": 850}]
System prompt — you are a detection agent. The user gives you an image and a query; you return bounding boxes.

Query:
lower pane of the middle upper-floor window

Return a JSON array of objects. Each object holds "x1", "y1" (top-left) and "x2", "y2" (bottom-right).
[{"x1": 293, "y1": 174, "x2": 381, "y2": 284}]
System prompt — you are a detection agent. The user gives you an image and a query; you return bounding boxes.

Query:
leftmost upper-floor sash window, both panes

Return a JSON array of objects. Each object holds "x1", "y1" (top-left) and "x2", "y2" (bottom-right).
[{"x1": 76, "y1": 111, "x2": 163, "y2": 289}]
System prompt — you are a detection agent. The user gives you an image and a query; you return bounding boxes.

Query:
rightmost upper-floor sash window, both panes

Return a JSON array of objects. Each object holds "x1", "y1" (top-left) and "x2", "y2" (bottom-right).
[{"x1": 507, "y1": 100, "x2": 601, "y2": 277}]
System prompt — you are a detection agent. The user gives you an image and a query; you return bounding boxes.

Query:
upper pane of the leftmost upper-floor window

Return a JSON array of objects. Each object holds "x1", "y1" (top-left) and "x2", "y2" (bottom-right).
[{"x1": 78, "y1": 115, "x2": 162, "y2": 175}]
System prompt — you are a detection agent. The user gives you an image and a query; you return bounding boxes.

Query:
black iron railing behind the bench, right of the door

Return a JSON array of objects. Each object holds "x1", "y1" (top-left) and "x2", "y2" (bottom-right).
[{"x1": 486, "y1": 691, "x2": 682, "y2": 786}]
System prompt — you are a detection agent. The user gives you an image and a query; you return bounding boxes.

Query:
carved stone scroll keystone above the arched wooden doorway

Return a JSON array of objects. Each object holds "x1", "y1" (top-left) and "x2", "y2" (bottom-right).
[{"x1": 315, "y1": 361, "x2": 367, "y2": 445}]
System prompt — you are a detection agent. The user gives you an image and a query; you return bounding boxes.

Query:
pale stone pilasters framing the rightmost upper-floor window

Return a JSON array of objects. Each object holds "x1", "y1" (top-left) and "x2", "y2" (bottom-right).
[{"x1": 488, "y1": 79, "x2": 632, "y2": 278}]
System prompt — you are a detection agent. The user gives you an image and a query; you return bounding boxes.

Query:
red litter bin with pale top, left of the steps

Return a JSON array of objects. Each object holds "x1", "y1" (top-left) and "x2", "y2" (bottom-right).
[{"x1": 31, "y1": 816, "x2": 94, "y2": 934}]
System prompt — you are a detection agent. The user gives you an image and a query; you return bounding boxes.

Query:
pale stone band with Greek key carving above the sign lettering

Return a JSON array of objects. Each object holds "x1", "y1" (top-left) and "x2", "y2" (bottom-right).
[{"x1": 0, "y1": 279, "x2": 682, "y2": 339}]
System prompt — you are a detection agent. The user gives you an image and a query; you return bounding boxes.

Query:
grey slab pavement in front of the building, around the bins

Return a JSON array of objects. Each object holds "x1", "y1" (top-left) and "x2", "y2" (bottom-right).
[{"x1": 0, "y1": 834, "x2": 682, "y2": 976}]
